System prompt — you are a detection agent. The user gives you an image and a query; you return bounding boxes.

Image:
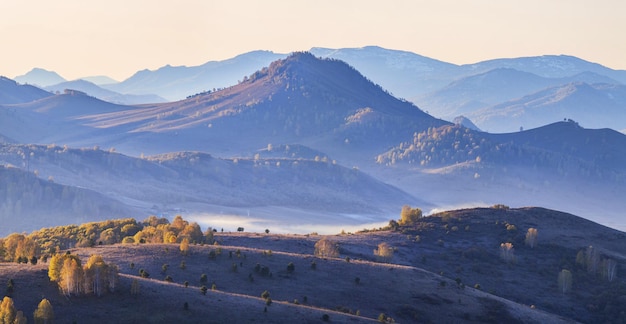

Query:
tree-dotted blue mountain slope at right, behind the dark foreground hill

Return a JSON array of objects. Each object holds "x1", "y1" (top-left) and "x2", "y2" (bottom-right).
[{"x1": 371, "y1": 122, "x2": 626, "y2": 229}]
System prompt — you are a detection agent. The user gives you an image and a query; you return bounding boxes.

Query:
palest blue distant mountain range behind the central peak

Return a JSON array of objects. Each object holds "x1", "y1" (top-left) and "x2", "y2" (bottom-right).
[{"x1": 11, "y1": 46, "x2": 626, "y2": 132}]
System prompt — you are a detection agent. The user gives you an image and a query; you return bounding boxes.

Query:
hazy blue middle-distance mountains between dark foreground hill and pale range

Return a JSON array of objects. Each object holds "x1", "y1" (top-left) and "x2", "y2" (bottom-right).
[{"x1": 0, "y1": 49, "x2": 626, "y2": 235}]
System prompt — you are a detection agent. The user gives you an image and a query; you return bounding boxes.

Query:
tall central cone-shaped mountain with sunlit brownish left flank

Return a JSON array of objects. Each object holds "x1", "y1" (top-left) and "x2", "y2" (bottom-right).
[{"x1": 73, "y1": 53, "x2": 447, "y2": 155}]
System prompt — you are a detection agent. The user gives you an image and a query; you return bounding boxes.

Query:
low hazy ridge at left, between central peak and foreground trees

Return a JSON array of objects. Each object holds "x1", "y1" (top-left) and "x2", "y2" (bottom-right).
[{"x1": 0, "y1": 145, "x2": 428, "y2": 234}]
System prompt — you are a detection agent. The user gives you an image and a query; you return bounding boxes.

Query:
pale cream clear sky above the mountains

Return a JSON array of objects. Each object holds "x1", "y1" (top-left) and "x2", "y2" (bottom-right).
[{"x1": 0, "y1": 0, "x2": 626, "y2": 81}]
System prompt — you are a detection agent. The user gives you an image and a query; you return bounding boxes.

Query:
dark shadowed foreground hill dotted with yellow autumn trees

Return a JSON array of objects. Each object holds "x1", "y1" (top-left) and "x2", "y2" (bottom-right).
[{"x1": 0, "y1": 206, "x2": 626, "y2": 323}]
